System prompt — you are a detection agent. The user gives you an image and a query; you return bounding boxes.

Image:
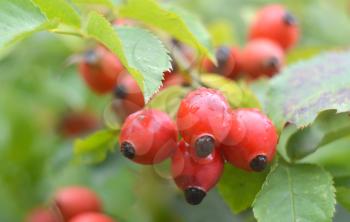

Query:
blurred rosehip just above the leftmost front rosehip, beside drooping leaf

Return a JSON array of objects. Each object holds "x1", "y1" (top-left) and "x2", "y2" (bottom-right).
[{"x1": 114, "y1": 74, "x2": 145, "y2": 117}]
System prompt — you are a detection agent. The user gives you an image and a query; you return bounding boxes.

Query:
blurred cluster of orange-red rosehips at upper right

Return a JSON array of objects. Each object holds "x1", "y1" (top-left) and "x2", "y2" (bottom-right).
[{"x1": 202, "y1": 4, "x2": 299, "y2": 79}]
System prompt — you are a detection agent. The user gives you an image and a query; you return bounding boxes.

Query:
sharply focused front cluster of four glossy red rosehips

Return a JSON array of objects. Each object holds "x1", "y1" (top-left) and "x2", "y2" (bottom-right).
[{"x1": 119, "y1": 88, "x2": 277, "y2": 204}]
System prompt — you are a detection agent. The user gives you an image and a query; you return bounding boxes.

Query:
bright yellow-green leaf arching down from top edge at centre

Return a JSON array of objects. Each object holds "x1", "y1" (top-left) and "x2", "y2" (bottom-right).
[{"x1": 120, "y1": 0, "x2": 214, "y2": 60}]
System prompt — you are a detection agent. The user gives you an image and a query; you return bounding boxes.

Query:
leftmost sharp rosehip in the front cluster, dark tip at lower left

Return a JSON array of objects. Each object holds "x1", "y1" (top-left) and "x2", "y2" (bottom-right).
[{"x1": 119, "y1": 109, "x2": 177, "y2": 164}]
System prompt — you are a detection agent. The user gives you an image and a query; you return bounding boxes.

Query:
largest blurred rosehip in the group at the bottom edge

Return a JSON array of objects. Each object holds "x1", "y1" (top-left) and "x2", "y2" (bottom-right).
[{"x1": 54, "y1": 186, "x2": 102, "y2": 220}]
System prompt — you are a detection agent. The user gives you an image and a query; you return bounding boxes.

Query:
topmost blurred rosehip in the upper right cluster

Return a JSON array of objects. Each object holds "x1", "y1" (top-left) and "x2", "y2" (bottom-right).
[{"x1": 249, "y1": 4, "x2": 299, "y2": 50}]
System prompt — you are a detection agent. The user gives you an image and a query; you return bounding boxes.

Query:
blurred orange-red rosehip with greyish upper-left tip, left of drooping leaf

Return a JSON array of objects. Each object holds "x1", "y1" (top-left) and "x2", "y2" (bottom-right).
[{"x1": 79, "y1": 46, "x2": 124, "y2": 94}]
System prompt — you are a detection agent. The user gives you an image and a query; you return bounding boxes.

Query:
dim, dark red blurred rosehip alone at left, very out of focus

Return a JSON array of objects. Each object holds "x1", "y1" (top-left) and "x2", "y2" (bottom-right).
[{"x1": 59, "y1": 111, "x2": 99, "y2": 138}]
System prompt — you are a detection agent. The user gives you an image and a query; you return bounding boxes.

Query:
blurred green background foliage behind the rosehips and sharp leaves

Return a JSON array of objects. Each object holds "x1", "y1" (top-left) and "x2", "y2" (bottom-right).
[{"x1": 0, "y1": 0, "x2": 350, "y2": 222}]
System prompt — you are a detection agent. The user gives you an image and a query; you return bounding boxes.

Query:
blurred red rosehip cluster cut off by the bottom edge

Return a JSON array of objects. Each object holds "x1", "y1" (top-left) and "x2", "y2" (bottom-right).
[{"x1": 25, "y1": 186, "x2": 116, "y2": 222}]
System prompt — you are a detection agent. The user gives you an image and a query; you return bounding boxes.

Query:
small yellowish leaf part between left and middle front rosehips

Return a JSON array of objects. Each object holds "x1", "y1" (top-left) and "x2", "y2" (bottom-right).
[{"x1": 147, "y1": 86, "x2": 189, "y2": 118}]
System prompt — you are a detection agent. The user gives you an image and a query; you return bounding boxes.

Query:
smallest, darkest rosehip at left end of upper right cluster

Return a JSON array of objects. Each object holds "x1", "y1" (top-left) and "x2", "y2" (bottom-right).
[{"x1": 202, "y1": 46, "x2": 236, "y2": 76}]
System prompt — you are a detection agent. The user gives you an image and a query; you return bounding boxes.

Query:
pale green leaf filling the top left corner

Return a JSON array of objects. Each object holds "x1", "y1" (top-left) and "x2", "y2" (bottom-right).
[{"x1": 0, "y1": 0, "x2": 56, "y2": 47}]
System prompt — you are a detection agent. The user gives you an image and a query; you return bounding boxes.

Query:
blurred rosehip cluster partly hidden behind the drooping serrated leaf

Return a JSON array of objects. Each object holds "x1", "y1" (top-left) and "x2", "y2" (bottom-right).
[{"x1": 79, "y1": 43, "x2": 185, "y2": 119}]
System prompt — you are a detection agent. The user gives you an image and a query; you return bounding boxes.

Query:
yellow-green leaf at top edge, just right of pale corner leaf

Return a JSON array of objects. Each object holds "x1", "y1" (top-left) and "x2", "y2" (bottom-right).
[{"x1": 33, "y1": 0, "x2": 80, "y2": 27}]
